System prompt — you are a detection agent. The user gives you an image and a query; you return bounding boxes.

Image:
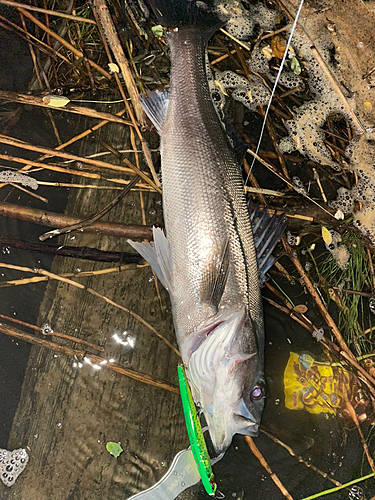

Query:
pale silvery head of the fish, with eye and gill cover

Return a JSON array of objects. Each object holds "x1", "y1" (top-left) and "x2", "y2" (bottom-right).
[{"x1": 187, "y1": 307, "x2": 265, "y2": 454}]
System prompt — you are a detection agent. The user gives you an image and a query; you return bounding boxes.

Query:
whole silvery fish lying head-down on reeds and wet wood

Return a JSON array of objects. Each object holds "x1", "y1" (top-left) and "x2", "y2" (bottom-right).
[{"x1": 129, "y1": 0, "x2": 283, "y2": 455}]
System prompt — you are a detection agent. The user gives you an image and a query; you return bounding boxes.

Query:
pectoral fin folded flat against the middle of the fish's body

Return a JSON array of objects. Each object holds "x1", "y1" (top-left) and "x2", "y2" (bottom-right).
[{"x1": 199, "y1": 239, "x2": 229, "y2": 311}]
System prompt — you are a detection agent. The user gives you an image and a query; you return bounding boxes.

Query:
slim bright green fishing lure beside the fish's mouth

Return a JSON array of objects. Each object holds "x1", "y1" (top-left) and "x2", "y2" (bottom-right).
[{"x1": 177, "y1": 365, "x2": 216, "y2": 496}]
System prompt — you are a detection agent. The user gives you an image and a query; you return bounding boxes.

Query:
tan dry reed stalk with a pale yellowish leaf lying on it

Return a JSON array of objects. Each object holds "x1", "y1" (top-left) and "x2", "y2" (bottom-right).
[{"x1": 0, "y1": 90, "x2": 132, "y2": 125}]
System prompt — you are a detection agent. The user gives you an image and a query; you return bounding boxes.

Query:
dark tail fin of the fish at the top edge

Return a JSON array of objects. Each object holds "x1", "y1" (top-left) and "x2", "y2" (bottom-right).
[{"x1": 148, "y1": 0, "x2": 225, "y2": 38}]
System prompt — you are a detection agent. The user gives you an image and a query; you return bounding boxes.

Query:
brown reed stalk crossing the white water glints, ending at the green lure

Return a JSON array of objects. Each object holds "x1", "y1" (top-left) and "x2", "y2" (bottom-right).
[{"x1": 0, "y1": 323, "x2": 179, "y2": 394}]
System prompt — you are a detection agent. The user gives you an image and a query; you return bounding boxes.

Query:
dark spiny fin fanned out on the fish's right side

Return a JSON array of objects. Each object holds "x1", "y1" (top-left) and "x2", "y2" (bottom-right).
[{"x1": 249, "y1": 203, "x2": 288, "y2": 285}]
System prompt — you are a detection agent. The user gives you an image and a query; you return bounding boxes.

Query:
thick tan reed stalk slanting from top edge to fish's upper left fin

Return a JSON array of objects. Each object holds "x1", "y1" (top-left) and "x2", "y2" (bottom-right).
[{"x1": 93, "y1": 0, "x2": 146, "y2": 128}]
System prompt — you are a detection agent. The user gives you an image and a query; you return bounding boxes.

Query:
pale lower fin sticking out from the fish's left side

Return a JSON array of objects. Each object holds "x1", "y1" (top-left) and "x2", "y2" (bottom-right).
[{"x1": 128, "y1": 227, "x2": 173, "y2": 293}]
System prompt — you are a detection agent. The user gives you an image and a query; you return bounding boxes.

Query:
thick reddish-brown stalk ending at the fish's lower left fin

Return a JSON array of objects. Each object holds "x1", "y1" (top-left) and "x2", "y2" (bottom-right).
[{"x1": 0, "y1": 202, "x2": 153, "y2": 241}]
